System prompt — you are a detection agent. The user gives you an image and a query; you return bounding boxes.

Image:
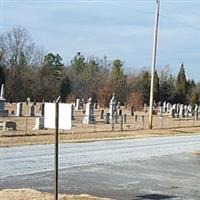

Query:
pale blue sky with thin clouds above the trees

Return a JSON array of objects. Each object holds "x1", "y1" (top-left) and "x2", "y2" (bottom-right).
[{"x1": 0, "y1": 0, "x2": 200, "y2": 81}]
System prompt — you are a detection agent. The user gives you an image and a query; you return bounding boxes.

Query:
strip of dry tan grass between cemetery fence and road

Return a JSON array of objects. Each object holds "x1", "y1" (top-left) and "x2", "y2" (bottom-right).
[{"x1": 0, "y1": 127, "x2": 200, "y2": 147}]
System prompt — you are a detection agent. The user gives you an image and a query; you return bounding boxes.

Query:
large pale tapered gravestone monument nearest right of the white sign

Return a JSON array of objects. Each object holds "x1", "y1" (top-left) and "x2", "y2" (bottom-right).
[{"x1": 83, "y1": 97, "x2": 95, "y2": 124}]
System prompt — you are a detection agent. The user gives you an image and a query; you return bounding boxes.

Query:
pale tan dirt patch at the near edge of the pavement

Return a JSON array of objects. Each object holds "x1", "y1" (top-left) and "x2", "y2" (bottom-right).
[{"x1": 0, "y1": 189, "x2": 109, "y2": 200}]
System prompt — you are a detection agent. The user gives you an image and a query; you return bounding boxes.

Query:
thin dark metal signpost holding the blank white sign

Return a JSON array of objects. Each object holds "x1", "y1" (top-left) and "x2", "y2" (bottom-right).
[{"x1": 54, "y1": 98, "x2": 59, "y2": 200}]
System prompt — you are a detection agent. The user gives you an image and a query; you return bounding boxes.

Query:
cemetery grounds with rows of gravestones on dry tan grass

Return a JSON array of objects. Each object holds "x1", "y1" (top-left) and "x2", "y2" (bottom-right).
[{"x1": 0, "y1": 90, "x2": 200, "y2": 142}]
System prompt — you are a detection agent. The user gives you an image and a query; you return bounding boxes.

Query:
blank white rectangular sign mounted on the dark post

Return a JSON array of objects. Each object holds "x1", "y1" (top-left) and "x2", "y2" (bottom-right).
[{"x1": 44, "y1": 103, "x2": 72, "y2": 130}]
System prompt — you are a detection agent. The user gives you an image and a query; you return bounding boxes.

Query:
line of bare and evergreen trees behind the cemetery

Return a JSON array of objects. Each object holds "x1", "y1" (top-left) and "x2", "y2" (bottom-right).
[{"x1": 0, "y1": 27, "x2": 200, "y2": 109}]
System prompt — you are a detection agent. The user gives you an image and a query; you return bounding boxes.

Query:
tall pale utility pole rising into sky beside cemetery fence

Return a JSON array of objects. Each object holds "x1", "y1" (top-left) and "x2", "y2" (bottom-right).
[{"x1": 149, "y1": 0, "x2": 160, "y2": 129}]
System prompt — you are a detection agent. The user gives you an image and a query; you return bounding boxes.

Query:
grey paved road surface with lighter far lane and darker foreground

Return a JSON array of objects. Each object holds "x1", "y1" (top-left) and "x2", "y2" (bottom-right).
[{"x1": 0, "y1": 136, "x2": 200, "y2": 200}]
